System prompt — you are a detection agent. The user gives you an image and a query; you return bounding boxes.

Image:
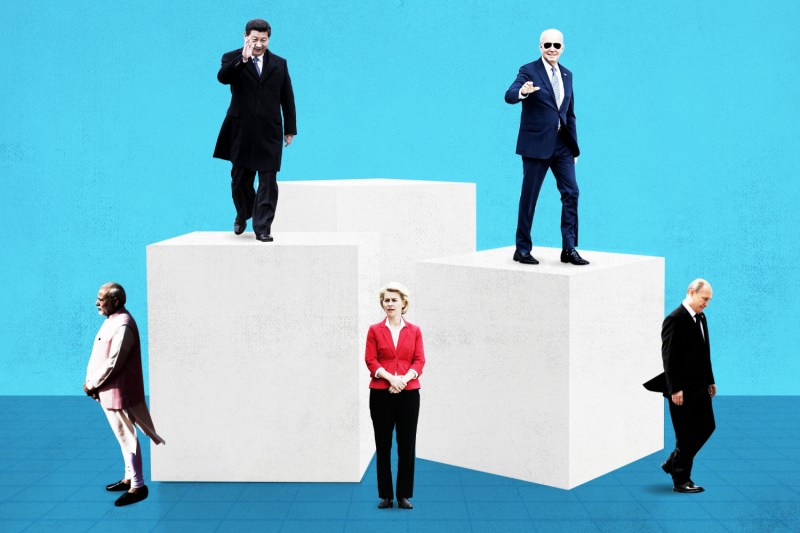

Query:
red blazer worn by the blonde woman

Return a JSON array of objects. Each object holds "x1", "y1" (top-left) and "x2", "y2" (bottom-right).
[{"x1": 364, "y1": 319, "x2": 425, "y2": 390}]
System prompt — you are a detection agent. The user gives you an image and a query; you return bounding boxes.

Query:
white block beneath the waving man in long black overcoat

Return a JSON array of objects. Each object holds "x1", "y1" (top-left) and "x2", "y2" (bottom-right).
[{"x1": 147, "y1": 232, "x2": 381, "y2": 482}]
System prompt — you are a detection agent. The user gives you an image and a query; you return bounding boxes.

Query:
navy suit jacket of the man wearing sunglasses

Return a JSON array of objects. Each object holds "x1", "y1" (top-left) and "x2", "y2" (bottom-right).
[{"x1": 506, "y1": 57, "x2": 580, "y2": 159}]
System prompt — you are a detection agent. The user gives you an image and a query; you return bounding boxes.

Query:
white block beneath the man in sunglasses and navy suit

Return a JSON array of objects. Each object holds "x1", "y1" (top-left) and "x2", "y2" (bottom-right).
[{"x1": 415, "y1": 247, "x2": 664, "y2": 489}]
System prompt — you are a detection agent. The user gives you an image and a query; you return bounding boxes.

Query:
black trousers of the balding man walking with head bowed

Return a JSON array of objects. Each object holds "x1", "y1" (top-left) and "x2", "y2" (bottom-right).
[{"x1": 667, "y1": 392, "x2": 717, "y2": 485}]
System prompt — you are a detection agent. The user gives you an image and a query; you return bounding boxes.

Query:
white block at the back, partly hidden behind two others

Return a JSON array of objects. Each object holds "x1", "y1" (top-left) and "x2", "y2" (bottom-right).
[{"x1": 272, "y1": 179, "x2": 476, "y2": 290}]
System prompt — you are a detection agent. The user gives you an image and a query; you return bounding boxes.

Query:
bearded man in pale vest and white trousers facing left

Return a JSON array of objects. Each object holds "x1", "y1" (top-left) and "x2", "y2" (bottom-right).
[{"x1": 83, "y1": 283, "x2": 164, "y2": 507}]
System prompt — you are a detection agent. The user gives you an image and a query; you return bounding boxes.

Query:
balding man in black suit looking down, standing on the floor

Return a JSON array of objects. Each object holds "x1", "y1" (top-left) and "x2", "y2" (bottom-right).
[{"x1": 644, "y1": 279, "x2": 717, "y2": 493}]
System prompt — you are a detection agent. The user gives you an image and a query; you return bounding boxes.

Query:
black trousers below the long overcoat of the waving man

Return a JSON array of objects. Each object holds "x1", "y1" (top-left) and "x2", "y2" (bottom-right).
[{"x1": 231, "y1": 165, "x2": 278, "y2": 235}]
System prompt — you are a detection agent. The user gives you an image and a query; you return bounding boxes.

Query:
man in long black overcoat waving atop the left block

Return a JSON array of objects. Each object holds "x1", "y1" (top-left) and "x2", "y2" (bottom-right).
[{"x1": 214, "y1": 19, "x2": 297, "y2": 242}]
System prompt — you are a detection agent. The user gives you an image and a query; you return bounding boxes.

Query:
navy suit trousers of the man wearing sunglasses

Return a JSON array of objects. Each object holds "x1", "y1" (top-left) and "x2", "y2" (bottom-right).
[{"x1": 516, "y1": 133, "x2": 580, "y2": 253}]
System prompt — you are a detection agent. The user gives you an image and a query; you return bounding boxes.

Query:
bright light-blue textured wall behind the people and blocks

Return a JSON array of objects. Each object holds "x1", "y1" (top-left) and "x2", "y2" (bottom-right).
[{"x1": 0, "y1": 0, "x2": 800, "y2": 395}]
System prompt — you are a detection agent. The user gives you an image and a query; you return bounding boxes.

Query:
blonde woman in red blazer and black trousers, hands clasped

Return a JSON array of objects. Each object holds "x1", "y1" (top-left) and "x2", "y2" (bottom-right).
[{"x1": 364, "y1": 282, "x2": 425, "y2": 509}]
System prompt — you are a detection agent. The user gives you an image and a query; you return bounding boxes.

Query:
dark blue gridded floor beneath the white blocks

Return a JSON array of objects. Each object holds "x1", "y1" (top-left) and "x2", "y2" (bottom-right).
[{"x1": 0, "y1": 396, "x2": 800, "y2": 533}]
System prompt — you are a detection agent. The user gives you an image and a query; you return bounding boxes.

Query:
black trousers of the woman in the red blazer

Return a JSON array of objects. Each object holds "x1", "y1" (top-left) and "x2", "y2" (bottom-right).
[{"x1": 369, "y1": 389, "x2": 419, "y2": 499}]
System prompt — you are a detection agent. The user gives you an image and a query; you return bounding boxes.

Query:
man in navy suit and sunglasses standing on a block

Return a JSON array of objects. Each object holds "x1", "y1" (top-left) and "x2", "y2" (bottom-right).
[{"x1": 506, "y1": 29, "x2": 589, "y2": 265}]
